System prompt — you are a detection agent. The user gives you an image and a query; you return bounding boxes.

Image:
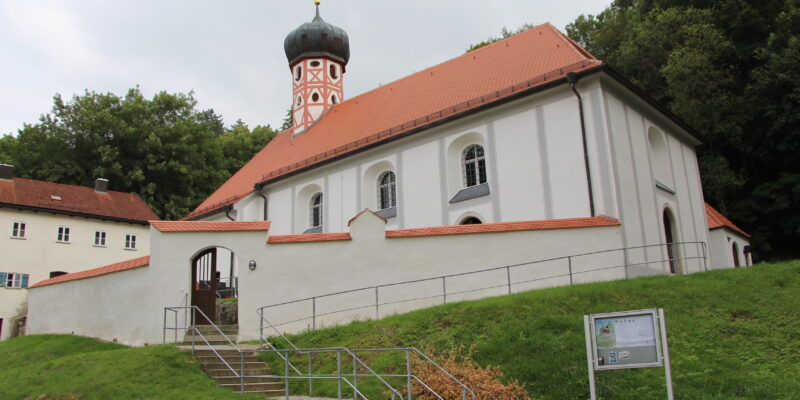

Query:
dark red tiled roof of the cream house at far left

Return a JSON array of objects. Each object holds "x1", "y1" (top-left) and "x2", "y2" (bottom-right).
[{"x1": 0, "y1": 178, "x2": 159, "y2": 223}]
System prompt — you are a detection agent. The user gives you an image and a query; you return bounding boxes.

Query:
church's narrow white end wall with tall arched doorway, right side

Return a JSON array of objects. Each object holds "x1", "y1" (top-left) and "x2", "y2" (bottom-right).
[{"x1": 599, "y1": 77, "x2": 708, "y2": 273}]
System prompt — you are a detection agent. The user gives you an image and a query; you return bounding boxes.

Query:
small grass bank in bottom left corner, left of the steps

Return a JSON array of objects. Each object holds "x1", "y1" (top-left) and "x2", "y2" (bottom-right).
[{"x1": 0, "y1": 335, "x2": 263, "y2": 400}]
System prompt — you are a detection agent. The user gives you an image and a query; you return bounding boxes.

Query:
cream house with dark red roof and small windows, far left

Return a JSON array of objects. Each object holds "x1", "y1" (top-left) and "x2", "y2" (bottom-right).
[{"x1": 0, "y1": 165, "x2": 158, "y2": 340}]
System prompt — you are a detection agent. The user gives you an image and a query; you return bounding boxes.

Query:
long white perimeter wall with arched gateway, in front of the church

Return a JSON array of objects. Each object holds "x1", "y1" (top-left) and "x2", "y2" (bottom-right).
[{"x1": 29, "y1": 213, "x2": 625, "y2": 345}]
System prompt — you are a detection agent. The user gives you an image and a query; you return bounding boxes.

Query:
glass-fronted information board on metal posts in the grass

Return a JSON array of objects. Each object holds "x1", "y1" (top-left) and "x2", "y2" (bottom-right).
[{"x1": 590, "y1": 310, "x2": 663, "y2": 370}]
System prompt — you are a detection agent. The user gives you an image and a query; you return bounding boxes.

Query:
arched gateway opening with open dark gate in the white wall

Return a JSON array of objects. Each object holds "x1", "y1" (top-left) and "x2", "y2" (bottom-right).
[{"x1": 191, "y1": 247, "x2": 239, "y2": 325}]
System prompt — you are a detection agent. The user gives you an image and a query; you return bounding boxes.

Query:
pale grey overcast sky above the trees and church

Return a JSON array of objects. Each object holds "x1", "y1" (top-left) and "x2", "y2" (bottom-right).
[{"x1": 0, "y1": 0, "x2": 611, "y2": 134}]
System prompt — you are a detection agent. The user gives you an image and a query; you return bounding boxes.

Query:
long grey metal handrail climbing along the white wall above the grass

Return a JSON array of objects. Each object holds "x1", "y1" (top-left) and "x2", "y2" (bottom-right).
[{"x1": 257, "y1": 241, "x2": 708, "y2": 329}]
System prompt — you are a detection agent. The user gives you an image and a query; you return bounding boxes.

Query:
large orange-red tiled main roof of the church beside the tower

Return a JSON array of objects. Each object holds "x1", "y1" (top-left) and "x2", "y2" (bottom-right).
[{"x1": 185, "y1": 24, "x2": 604, "y2": 219}]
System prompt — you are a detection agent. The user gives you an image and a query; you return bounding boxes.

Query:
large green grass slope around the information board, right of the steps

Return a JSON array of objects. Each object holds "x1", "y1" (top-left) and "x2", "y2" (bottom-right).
[{"x1": 268, "y1": 261, "x2": 800, "y2": 400}]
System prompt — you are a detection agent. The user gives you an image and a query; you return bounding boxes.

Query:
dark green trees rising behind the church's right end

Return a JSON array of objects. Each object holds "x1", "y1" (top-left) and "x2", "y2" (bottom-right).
[{"x1": 567, "y1": 0, "x2": 800, "y2": 258}]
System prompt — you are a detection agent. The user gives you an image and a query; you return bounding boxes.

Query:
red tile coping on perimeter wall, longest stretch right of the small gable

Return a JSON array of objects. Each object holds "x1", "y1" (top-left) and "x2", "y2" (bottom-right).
[{"x1": 386, "y1": 215, "x2": 620, "y2": 238}]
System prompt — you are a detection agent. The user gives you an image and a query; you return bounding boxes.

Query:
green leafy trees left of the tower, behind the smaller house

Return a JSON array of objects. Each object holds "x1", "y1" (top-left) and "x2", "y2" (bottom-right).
[{"x1": 0, "y1": 88, "x2": 275, "y2": 219}]
